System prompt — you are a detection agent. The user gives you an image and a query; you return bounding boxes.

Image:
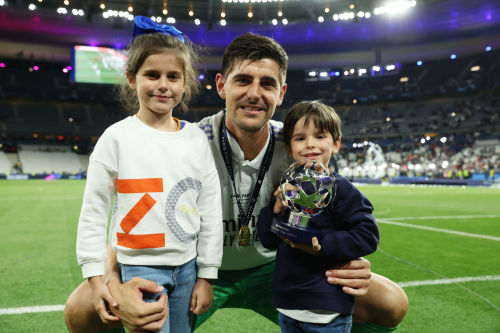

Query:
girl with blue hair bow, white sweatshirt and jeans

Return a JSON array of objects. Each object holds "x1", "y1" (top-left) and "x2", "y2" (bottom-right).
[{"x1": 77, "y1": 17, "x2": 222, "y2": 333}]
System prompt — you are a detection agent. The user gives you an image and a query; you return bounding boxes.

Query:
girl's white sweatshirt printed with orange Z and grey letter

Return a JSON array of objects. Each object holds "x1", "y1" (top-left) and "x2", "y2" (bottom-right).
[{"x1": 77, "y1": 116, "x2": 222, "y2": 279}]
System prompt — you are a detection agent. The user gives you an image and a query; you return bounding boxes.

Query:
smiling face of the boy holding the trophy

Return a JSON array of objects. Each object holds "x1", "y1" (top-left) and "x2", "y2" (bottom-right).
[{"x1": 288, "y1": 117, "x2": 340, "y2": 166}]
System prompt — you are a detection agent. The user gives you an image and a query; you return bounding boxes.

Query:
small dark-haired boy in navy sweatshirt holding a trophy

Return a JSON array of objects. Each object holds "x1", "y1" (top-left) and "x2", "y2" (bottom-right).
[{"x1": 257, "y1": 101, "x2": 379, "y2": 332}]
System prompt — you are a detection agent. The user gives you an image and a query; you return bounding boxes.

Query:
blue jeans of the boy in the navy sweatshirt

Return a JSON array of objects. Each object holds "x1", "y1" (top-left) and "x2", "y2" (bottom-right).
[{"x1": 278, "y1": 313, "x2": 352, "y2": 333}]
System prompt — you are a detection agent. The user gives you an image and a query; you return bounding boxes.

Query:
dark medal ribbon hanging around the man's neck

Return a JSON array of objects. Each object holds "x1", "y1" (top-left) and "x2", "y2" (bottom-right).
[{"x1": 220, "y1": 111, "x2": 275, "y2": 246}]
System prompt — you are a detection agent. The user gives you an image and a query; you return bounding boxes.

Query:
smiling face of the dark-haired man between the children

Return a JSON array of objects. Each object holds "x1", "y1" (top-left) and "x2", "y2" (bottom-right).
[{"x1": 215, "y1": 58, "x2": 286, "y2": 134}]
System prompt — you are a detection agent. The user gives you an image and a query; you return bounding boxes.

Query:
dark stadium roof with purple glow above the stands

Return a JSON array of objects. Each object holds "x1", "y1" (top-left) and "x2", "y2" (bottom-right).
[{"x1": 0, "y1": 0, "x2": 500, "y2": 65}]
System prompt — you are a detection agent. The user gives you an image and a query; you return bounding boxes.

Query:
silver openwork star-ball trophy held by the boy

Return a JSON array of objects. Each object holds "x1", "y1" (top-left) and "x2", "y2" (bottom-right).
[{"x1": 271, "y1": 160, "x2": 336, "y2": 244}]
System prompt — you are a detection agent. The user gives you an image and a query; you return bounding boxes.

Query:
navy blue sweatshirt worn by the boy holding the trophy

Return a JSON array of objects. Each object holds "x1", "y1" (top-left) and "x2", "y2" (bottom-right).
[{"x1": 257, "y1": 173, "x2": 379, "y2": 314}]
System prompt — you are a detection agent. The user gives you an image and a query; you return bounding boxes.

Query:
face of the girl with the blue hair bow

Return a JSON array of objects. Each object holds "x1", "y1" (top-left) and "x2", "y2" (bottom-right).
[{"x1": 127, "y1": 49, "x2": 184, "y2": 116}]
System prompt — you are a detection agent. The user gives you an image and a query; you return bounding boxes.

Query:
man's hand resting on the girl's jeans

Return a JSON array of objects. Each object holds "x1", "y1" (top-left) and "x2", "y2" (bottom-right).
[{"x1": 108, "y1": 278, "x2": 168, "y2": 332}]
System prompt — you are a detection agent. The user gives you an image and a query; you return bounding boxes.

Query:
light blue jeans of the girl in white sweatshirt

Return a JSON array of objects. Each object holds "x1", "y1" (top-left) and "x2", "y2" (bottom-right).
[{"x1": 120, "y1": 258, "x2": 196, "y2": 333}]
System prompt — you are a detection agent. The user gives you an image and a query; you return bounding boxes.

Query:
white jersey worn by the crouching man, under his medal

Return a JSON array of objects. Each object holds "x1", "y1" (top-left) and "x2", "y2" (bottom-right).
[{"x1": 198, "y1": 111, "x2": 292, "y2": 270}]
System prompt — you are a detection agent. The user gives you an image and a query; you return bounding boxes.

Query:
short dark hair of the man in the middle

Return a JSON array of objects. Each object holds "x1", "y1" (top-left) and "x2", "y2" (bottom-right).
[{"x1": 221, "y1": 32, "x2": 288, "y2": 85}]
